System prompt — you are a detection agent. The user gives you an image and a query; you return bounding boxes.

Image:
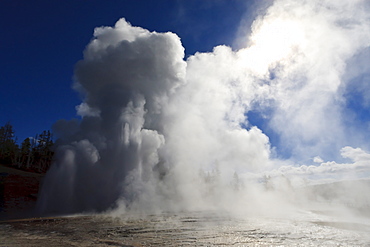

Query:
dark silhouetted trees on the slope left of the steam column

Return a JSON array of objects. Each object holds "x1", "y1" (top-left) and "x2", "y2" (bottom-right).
[{"x1": 0, "y1": 123, "x2": 54, "y2": 173}]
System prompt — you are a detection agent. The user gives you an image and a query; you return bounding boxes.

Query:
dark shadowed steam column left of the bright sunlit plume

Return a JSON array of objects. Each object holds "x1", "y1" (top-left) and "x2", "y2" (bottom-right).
[{"x1": 36, "y1": 19, "x2": 186, "y2": 212}]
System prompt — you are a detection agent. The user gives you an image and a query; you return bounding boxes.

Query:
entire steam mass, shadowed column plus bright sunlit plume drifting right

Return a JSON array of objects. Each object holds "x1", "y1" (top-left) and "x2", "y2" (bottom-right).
[{"x1": 38, "y1": 0, "x2": 370, "y2": 215}]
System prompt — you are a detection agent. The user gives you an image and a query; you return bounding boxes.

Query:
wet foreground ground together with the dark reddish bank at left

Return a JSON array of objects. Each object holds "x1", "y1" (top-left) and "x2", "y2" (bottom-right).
[{"x1": 0, "y1": 166, "x2": 370, "y2": 247}]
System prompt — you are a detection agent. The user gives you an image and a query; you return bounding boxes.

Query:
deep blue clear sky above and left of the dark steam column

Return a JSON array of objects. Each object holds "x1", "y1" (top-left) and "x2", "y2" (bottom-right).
[{"x1": 0, "y1": 0, "x2": 255, "y2": 142}]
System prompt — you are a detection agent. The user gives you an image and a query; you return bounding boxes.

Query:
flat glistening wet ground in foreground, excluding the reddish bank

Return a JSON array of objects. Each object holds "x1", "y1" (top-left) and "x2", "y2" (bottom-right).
[{"x1": 0, "y1": 212, "x2": 370, "y2": 246}]
